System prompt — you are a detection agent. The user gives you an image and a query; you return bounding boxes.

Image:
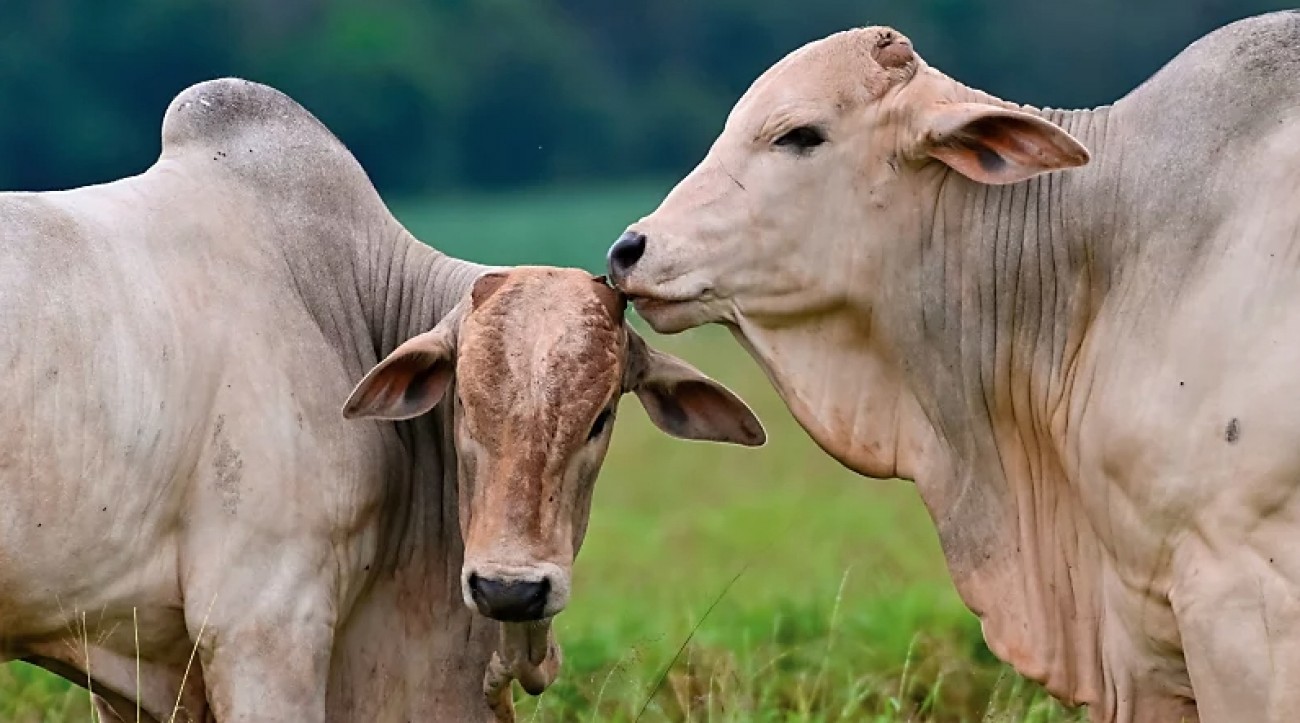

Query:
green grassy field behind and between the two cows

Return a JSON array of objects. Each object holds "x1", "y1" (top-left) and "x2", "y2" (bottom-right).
[{"x1": 0, "y1": 183, "x2": 1083, "y2": 723}]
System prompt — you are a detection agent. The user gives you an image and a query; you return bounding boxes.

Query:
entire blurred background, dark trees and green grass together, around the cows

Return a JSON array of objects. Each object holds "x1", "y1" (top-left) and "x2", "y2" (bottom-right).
[{"x1": 0, "y1": 0, "x2": 1286, "y2": 720}]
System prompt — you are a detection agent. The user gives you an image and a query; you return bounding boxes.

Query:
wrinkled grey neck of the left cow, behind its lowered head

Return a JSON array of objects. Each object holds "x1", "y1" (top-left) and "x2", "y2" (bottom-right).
[{"x1": 289, "y1": 216, "x2": 508, "y2": 720}]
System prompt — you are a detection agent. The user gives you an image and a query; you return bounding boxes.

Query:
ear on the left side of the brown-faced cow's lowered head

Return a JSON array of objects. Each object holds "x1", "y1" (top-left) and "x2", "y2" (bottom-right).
[{"x1": 343, "y1": 319, "x2": 456, "y2": 420}]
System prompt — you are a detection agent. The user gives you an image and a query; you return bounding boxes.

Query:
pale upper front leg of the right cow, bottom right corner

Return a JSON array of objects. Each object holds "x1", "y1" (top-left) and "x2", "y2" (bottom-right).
[{"x1": 1171, "y1": 551, "x2": 1300, "y2": 723}]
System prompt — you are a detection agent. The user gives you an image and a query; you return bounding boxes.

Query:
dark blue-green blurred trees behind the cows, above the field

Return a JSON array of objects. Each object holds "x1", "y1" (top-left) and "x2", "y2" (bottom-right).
[{"x1": 0, "y1": 0, "x2": 1287, "y2": 194}]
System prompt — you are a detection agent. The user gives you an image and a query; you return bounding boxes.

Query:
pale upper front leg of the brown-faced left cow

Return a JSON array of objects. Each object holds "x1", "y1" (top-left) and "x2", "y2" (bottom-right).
[{"x1": 186, "y1": 566, "x2": 335, "y2": 723}]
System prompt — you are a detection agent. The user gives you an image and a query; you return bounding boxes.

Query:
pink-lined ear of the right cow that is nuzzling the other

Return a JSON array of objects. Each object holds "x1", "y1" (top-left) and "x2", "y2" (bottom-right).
[{"x1": 919, "y1": 103, "x2": 1089, "y2": 185}]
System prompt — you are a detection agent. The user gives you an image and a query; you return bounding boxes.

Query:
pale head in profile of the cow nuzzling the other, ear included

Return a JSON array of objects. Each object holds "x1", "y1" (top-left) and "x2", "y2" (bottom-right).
[{"x1": 608, "y1": 27, "x2": 1088, "y2": 333}]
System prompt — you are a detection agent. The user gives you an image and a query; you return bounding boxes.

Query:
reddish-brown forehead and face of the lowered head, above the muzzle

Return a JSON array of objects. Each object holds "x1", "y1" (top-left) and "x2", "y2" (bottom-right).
[{"x1": 456, "y1": 267, "x2": 625, "y2": 564}]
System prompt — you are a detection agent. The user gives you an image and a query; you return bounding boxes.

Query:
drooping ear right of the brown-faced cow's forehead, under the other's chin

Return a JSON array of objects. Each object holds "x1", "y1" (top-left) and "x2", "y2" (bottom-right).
[{"x1": 625, "y1": 328, "x2": 767, "y2": 447}]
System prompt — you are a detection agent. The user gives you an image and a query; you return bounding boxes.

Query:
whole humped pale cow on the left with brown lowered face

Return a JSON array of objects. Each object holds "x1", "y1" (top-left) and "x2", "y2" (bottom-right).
[{"x1": 0, "y1": 79, "x2": 763, "y2": 722}]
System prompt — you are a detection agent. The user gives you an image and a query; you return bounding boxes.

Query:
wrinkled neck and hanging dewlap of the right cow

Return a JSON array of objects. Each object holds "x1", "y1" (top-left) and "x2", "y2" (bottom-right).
[{"x1": 733, "y1": 91, "x2": 1126, "y2": 702}]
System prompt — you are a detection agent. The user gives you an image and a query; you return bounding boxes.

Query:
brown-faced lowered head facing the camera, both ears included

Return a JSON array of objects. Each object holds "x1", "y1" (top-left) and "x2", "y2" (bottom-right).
[{"x1": 345, "y1": 267, "x2": 766, "y2": 623}]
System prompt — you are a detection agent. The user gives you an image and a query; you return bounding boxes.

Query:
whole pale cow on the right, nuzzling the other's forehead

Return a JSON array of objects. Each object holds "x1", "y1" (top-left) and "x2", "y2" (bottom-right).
[{"x1": 608, "y1": 12, "x2": 1300, "y2": 723}]
